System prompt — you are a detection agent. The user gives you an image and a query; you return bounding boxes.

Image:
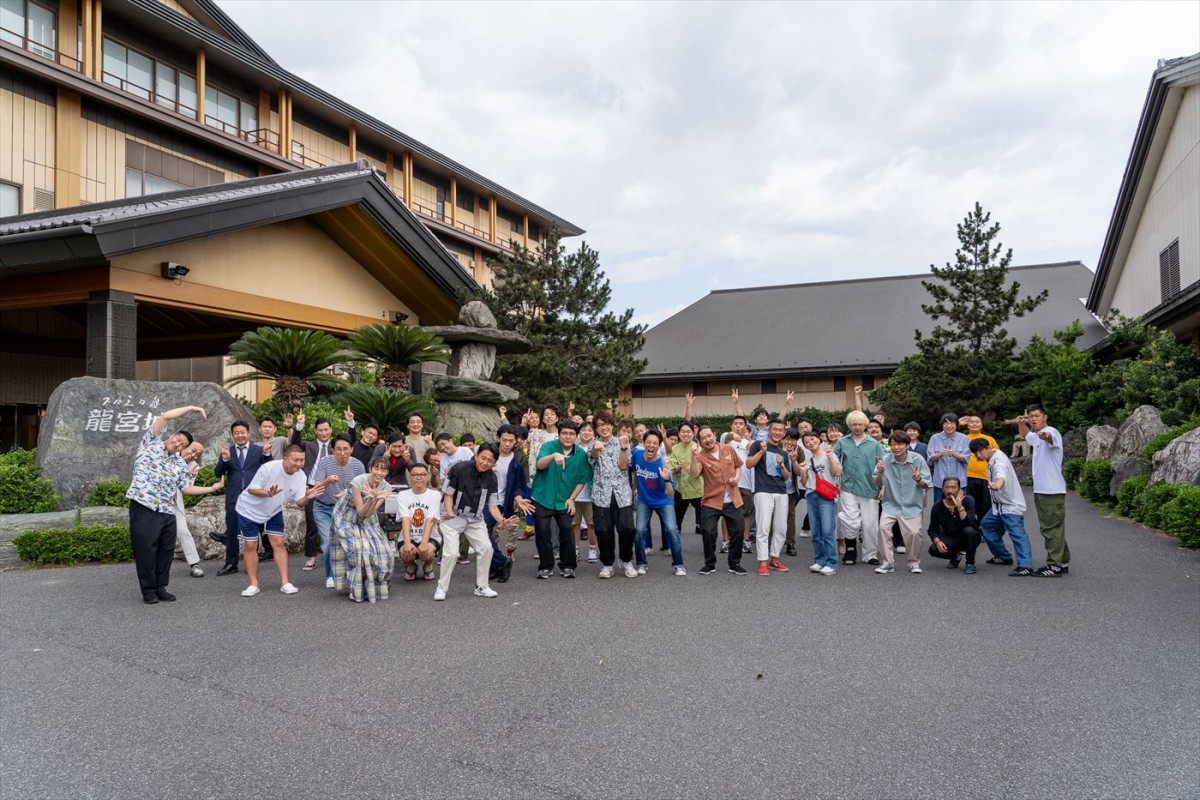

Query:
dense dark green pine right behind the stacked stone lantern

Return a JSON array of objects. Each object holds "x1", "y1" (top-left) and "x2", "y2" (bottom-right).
[{"x1": 463, "y1": 225, "x2": 646, "y2": 409}]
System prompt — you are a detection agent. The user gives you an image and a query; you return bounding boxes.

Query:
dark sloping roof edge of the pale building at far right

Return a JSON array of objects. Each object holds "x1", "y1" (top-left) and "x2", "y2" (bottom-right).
[{"x1": 1087, "y1": 53, "x2": 1200, "y2": 313}]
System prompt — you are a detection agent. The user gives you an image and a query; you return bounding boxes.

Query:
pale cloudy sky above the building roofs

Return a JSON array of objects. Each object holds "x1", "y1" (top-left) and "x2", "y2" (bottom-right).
[{"x1": 221, "y1": 0, "x2": 1200, "y2": 325}]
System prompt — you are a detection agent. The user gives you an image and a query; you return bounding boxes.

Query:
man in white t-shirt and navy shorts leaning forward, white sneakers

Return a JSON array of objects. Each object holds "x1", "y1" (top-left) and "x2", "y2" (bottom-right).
[{"x1": 236, "y1": 445, "x2": 337, "y2": 597}]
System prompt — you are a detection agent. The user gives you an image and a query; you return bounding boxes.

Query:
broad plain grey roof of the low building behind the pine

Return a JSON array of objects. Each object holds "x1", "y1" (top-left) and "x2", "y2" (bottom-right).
[{"x1": 636, "y1": 261, "x2": 1104, "y2": 383}]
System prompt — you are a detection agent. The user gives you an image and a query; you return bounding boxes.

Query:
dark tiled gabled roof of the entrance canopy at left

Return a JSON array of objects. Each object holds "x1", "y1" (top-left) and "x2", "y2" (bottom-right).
[{"x1": 0, "y1": 161, "x2": 476, "y2": 317}]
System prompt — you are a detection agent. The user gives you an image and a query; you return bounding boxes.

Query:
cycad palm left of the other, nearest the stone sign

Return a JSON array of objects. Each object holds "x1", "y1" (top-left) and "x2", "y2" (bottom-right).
[{"x1": 226, "y1": 326, "x2": 342, "y2": 408}]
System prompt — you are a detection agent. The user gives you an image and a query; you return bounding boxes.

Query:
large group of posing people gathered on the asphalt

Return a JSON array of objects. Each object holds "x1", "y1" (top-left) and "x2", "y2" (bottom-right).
[{"x1": 128, "y1": 387, "x2": 1070, "y2": 603}]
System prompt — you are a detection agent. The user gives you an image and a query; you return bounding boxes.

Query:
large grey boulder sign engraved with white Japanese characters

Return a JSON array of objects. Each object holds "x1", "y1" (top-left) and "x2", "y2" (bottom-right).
[{"x1": 37, "y1": 378, "x2": 253, "y2": 509}]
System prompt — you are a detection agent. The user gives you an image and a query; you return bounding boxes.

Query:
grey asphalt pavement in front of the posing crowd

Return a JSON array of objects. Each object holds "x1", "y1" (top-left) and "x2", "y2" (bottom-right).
[{"x1": 0, "y1": 489, "x2": 1200, "y2": 799}]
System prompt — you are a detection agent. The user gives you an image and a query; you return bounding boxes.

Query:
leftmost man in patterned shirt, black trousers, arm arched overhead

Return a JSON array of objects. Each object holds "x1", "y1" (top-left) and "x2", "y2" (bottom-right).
[{"x1": 125, "y1": 405, "x2": 208, "y2": 606}]
